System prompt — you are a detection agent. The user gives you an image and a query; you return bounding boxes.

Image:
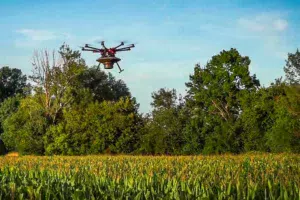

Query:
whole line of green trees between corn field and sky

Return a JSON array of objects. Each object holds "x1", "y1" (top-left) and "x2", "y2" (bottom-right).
[{"x1": 0, "y1": 44, "x2": 300, "y2": 155}]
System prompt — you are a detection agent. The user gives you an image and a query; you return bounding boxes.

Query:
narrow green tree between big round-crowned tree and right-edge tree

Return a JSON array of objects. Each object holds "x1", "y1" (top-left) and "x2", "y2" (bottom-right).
[{"x1": 241, "y1": 79, "x2": 286, "y2": 151}]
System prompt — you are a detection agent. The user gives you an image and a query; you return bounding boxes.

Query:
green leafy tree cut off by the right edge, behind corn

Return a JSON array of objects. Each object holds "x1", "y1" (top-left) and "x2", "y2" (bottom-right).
[{"x1": 266, "y1": 83, "x2": 300, "y2": 153}]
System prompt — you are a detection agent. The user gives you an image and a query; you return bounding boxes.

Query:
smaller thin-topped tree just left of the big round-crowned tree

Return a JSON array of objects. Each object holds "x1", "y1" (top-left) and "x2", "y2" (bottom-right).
[{"x1": 141, "y1": 88, "x2": 186, "y2": 154}]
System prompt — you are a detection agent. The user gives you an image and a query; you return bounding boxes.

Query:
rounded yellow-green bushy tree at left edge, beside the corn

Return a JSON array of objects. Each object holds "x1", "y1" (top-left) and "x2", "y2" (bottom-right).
[{"x1": 1, "y1": 96, "x2": 48, "y2": 155}]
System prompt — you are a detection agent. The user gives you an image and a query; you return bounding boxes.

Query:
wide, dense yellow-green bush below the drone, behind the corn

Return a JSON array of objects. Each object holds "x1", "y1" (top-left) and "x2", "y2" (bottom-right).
[{"x1": 45, "y1": 98, "x2": 142, "y2": 155}]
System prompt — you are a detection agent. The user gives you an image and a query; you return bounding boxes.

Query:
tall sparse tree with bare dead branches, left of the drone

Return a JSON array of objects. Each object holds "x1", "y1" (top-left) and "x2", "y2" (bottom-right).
[{"x1": 30, "y1": 44, "x2": 87, "y2": 124}]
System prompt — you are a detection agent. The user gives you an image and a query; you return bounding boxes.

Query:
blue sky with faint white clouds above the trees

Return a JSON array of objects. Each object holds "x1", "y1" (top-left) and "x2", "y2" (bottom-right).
[{"x1": 0, "y1": 0, "x2": 300, "y2": 113}]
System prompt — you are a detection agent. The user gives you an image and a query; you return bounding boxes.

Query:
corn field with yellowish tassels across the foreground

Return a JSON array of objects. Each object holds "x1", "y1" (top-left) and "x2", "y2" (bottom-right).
[{"x1": 0, "y1": 154, "x2": 300, "y2": 200}]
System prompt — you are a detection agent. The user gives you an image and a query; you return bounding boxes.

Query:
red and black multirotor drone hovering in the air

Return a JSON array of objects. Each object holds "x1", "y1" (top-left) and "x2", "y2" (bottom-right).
[{"x1": 81, "y1": 41, "x2": 135, "y2": 73}]
